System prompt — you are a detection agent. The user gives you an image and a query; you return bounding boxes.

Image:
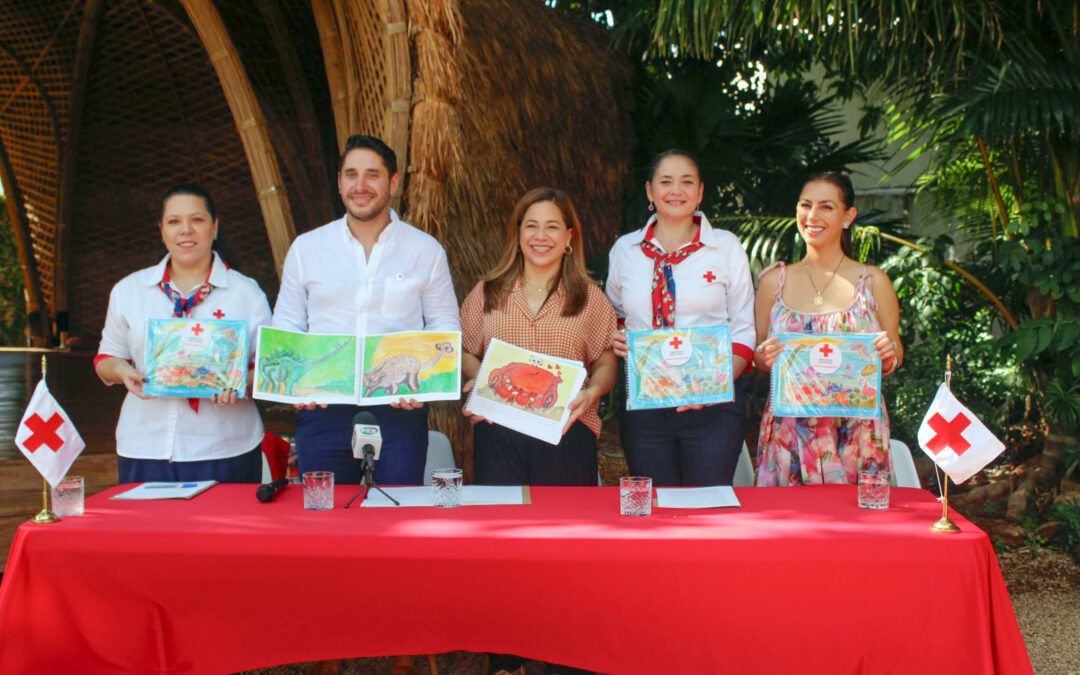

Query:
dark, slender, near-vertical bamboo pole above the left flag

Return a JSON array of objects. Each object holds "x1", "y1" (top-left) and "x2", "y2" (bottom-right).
[{"x1": 53, "y1": 0, "x2": 105, "y2": 347}]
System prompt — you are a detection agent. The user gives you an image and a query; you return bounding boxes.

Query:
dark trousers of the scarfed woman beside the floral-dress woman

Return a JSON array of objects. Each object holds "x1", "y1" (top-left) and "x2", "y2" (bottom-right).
[{"x1": 619, "y1": 378, "x2": 746, "y2": 486}]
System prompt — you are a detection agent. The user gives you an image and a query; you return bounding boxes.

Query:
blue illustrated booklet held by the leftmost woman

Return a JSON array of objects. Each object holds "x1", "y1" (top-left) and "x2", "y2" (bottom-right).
[{"x1": 144, "y1": 319, "x2": 247, "y2": 399}]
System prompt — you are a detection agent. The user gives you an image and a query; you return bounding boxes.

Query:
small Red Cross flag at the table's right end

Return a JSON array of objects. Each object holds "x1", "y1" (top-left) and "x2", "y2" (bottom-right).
[{"x1": 919, "y1": 383, "x2": 1005, "y2": 485}]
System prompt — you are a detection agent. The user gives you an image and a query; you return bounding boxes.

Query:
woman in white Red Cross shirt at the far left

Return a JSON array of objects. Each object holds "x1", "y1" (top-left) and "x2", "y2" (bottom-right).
[{"x1": 94, "y1": 185, "x2": 270, "y2": 483}]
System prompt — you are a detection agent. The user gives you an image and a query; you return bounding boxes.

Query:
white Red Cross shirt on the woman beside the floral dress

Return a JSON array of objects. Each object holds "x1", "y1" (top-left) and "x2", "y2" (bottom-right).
[{"x1": 605, "y1": 212, "x2": 757, "y2": 361}]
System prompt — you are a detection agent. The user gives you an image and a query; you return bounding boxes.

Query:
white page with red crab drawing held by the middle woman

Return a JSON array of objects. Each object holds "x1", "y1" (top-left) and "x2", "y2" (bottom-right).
[{"x1": 465, "y1": 339, "x2": 586, "y2": 445}]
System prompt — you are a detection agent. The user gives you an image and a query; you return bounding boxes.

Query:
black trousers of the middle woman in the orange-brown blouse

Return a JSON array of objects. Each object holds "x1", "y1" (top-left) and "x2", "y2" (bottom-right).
[{"x1": 473, "y1": 421, "x2": 597, "y2": 486}]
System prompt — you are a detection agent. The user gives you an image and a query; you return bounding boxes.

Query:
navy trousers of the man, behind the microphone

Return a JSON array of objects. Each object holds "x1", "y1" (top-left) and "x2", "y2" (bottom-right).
[{"x1": 296, "y1": 405, "x2": 428, "y2": 485}]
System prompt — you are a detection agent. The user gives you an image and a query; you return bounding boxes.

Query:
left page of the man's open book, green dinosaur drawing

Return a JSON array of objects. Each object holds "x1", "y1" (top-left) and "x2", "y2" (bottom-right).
[{"x1": 254, "y1": 326, "x2": 356, "y2": 403}]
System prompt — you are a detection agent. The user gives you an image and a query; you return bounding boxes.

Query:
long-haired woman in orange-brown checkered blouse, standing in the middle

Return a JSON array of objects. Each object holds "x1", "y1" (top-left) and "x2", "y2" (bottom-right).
[{"x1": 461, "y1": 188, "x2": 618, "y2": 485}]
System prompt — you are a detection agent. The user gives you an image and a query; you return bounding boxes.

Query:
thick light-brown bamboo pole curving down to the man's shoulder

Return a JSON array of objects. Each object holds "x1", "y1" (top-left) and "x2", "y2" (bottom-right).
[{"x1": 180, "y1": 0, "x2": 296, "y2": 276}]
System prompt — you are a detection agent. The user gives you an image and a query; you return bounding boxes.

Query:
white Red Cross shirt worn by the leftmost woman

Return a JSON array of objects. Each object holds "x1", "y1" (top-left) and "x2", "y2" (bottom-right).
[{"x1": 97, "y1": 253, "x2": 270, "y2": 461}]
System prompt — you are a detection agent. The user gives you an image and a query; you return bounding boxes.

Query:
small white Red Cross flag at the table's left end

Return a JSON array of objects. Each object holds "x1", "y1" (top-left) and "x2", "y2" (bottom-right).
[{"x1": 15, "y1": 380, "x2": 86, "y2": 486}]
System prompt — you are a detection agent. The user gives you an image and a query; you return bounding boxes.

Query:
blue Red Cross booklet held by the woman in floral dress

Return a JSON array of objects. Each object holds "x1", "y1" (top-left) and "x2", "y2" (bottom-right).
[{"x1": 770, "y1": 333, "x2": 881, "y2": 418}]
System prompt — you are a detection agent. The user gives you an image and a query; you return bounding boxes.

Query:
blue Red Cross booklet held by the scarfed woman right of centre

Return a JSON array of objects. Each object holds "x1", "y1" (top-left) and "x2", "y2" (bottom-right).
[{"x1": 626, "y1": 326, "x2": 734, "y2": 409}]
